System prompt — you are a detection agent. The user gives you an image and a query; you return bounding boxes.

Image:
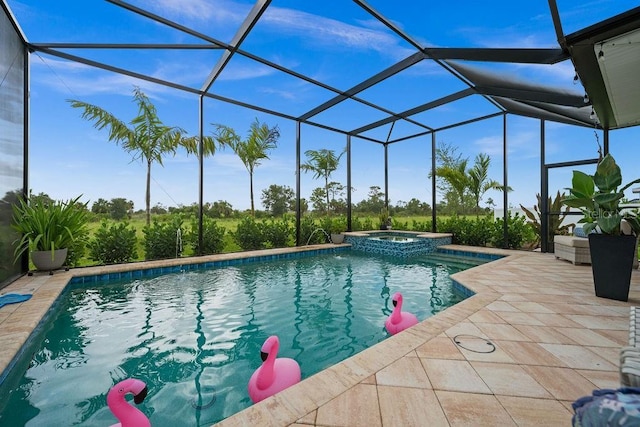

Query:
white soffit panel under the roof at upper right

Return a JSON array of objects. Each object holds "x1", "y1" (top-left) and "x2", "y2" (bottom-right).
[{"x1": 593, "y1": 29, "x2": 640, "y2": 127}]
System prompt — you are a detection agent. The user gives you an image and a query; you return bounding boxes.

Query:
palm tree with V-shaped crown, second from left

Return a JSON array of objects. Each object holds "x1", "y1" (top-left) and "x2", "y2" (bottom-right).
[{"x1": 213, "y1": 118, "x2": 280, "y2": 215}]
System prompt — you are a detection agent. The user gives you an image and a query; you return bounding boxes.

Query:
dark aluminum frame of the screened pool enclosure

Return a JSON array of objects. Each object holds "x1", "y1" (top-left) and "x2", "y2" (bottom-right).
[{"x1": 0, "y1": 0, "x2": 640, "y2": 262}]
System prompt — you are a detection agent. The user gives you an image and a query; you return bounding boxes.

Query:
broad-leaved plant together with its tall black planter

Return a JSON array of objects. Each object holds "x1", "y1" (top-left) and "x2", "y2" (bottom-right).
[{"x1": 563, "y1": 154, "x2": 640, "y2": 301}]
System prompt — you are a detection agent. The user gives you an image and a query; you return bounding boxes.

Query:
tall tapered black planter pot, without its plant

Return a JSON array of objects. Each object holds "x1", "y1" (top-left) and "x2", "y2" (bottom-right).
[{"x1": 589, "y1": 233, "x2": 636, "y2": 301}]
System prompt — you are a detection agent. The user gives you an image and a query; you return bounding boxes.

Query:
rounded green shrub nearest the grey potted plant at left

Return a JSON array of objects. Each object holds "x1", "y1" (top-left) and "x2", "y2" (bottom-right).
[{"x1": 89, "y1": 221, "x2": 138, "y2": 264}]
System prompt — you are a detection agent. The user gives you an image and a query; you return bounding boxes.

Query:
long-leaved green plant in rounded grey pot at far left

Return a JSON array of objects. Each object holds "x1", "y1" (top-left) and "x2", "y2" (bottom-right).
[{"x1": 11, "y1": 196, "x2": 87, "y2": 271}]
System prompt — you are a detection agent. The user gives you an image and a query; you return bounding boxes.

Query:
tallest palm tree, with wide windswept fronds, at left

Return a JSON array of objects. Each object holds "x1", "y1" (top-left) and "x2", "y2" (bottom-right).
[{"x1": 68, "y1": 87, "x2": 215, "y2": 225}]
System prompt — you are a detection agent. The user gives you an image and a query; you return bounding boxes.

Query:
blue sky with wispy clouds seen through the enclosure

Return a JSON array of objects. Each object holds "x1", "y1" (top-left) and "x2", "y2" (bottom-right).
[{"x1": 8, "y1": 0, "x2": 640, "y2": 213}]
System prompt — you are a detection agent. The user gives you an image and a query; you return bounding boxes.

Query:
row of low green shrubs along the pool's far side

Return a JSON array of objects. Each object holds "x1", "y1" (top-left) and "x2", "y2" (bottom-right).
[{"x1": 82, "y1": 214, "x2": 536, "y2": 265}]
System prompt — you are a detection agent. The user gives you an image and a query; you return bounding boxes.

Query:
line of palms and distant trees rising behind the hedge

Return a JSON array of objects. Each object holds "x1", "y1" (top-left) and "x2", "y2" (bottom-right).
[{"x1": 69, "y1": 87, "x2": 509, "y2": 225}]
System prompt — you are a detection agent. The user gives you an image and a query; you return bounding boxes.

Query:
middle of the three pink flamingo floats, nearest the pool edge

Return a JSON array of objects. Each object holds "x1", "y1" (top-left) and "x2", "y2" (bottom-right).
[{"x1": 249, "y1": 335, "x2": 300, "y2": 403}]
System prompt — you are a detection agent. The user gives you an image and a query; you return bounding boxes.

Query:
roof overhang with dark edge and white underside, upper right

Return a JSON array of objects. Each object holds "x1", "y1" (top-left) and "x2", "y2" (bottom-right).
[{"x1": 565, "y1": 7, "x2": 640, "y2": 129}]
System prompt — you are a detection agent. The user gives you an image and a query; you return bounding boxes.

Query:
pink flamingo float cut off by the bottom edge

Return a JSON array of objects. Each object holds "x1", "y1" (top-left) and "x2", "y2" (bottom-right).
[{"x1": 107, "y1": 378, "x2": 151, "y2": 427}]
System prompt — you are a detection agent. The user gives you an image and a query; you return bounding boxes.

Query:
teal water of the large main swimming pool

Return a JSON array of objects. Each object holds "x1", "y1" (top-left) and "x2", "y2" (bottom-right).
[{"x1": 0, "y1": 251, "x2": 470, "y2": 427}]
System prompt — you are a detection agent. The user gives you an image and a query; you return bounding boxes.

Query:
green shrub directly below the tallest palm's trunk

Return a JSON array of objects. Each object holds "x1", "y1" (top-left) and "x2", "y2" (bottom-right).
[{"x1": 142, "y1": 215, "x2": 183, "y2": 260}]
